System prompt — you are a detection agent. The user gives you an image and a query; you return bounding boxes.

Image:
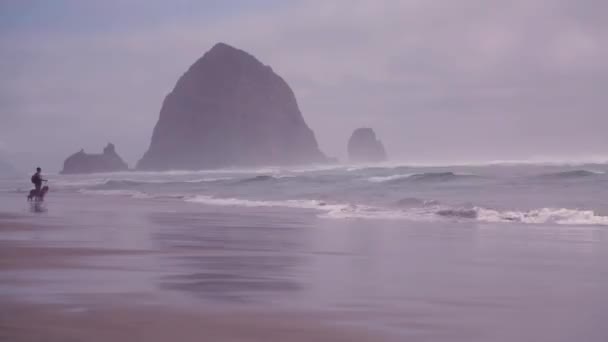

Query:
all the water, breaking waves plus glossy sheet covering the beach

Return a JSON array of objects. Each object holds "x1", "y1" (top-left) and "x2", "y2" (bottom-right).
[{"x1": 0, "y1": 164, "x2": 608, "y2": 341}]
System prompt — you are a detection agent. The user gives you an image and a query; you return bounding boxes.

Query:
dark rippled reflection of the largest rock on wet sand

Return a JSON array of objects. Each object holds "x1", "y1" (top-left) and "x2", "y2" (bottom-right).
[{"x1": 150, "y1": 213, "x2": 307, "y2": 303}]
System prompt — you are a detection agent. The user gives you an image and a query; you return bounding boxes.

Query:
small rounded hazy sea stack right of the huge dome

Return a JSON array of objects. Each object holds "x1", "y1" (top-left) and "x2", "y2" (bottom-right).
[{"x1": 348, "y1": 128, "x2": 387, "y2": 163}]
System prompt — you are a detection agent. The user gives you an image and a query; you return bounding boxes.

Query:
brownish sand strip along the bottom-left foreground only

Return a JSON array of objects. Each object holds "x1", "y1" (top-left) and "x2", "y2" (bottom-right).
[{"x1": 0, "y1": 301, "x2": 385, "y2": 342}]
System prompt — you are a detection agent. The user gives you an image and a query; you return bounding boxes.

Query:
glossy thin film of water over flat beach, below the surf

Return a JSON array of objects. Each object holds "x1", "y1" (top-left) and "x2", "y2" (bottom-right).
[{"x1": 0, "y1": 193, "x2": 608, "y2": 341}]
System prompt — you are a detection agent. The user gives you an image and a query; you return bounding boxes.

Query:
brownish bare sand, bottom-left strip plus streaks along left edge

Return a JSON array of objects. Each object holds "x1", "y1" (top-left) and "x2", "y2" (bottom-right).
[{"x1": 0, "y1": 213, "x2": 388, "y2": 342}]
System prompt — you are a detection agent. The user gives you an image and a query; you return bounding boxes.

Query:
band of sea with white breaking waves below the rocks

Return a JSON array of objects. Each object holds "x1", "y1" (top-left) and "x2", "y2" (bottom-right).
[{"x1": 0, "y1": 164, "x2": 608, "y2": 226}]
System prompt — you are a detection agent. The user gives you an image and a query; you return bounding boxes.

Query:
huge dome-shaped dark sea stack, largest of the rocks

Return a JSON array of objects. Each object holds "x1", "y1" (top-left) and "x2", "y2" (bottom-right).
[{"x1": 137, "y1": 43, "x2": 326, "y2": 170}]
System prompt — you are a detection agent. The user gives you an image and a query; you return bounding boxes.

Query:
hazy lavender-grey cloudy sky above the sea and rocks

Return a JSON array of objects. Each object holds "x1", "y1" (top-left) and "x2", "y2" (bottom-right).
[{"x1": 0, "y1": 0, "x2": 608, "y2": 170}]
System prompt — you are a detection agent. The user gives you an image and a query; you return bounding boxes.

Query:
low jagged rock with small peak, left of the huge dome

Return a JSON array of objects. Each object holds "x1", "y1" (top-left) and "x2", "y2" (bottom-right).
[{"x1": 61, "y1": 143, "x2": 129, "y2": 174}]
